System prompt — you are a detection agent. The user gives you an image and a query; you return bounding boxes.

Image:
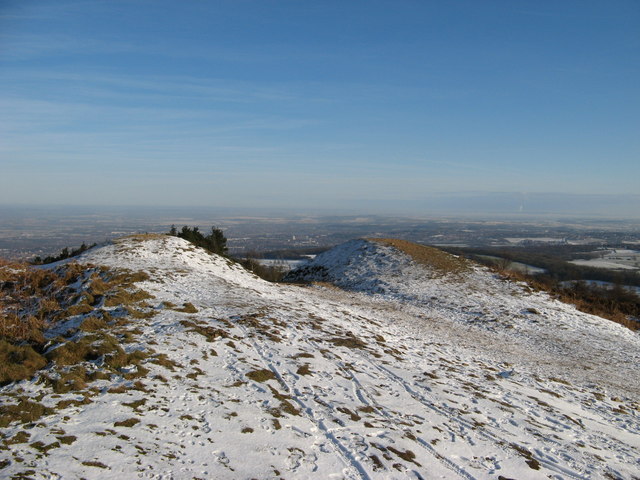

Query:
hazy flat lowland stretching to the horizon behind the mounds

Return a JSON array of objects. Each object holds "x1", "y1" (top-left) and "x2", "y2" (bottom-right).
[{"x1": 0, "y1": 207, "x2": 640, "y2": 268}]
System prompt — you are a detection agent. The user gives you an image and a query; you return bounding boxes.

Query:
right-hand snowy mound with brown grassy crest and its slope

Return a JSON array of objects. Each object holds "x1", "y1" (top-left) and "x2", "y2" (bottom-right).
[{"x1": 289, "y1": 240, "x2": 640, "y2": 398}]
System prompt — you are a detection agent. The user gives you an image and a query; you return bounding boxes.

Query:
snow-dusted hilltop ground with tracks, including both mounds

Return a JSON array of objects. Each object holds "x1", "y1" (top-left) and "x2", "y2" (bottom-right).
[{"x1": 0, "y1": 237, "x2": 640, "y2": 479}]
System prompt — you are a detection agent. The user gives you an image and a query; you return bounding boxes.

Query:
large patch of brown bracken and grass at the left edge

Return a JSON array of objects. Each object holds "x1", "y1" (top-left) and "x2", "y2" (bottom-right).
[{"x1": 0, "y1": 261, "x2": 162, "y2": 428}]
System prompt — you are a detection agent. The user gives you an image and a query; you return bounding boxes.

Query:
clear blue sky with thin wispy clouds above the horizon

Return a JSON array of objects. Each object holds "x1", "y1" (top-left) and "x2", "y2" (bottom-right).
[{"x1": 0, "y1": 0, "x2": 640, "y2": 213}]
